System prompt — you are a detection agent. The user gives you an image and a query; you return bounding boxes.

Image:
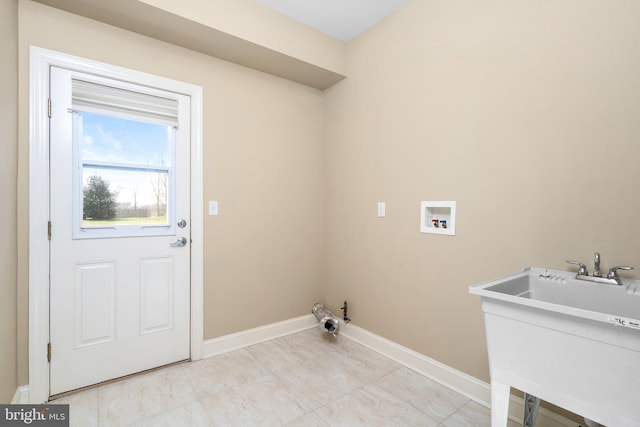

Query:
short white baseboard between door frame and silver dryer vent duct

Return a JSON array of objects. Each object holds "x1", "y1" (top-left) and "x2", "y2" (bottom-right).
[{"x1": 203, "y1": 314, "x2": 318, "y2": 359}]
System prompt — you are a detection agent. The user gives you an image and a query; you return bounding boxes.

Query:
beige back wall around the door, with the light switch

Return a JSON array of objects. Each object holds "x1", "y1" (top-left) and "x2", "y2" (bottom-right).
[{"x1": 18, "y1": 0, "x2": 323, "y2": 384}]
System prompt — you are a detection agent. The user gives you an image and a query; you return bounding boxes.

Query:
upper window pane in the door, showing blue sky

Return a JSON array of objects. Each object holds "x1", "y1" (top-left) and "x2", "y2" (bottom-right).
[{"x1": 78, "y1": 112, "x2": 173, "y2": 166}]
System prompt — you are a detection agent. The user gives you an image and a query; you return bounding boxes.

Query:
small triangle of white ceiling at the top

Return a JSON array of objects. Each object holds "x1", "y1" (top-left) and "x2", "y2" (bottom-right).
[{"x1": 256, "y1": 0, "x2": 408, "y2": 41}]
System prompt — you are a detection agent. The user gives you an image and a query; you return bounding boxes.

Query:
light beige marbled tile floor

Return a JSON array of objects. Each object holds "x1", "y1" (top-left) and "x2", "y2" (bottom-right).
[{"x1": 53, "y1": 328, "x2": 516, "y2": 427}]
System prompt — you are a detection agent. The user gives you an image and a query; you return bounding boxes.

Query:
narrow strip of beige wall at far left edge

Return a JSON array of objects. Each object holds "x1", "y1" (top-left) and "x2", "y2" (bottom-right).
[{"x1": 0, "y1": 0, "x2": 18, "y2": 403}]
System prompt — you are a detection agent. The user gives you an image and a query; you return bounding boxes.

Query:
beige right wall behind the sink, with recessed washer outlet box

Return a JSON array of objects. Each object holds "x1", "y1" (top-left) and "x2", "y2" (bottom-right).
[{"x1": 324, "y1": 0, "x2": 640, "y2": 380}]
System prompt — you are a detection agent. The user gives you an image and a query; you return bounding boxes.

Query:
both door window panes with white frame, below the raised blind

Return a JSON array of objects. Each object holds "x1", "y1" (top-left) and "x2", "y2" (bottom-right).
[{"x1": 74, "y1": 112, "x2": 175, "y2": 234}]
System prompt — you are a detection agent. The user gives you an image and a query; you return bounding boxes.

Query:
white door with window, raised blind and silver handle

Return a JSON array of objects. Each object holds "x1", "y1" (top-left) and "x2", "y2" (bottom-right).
[{"x1": 50, "y1": 67, "x2": 191, "y2": 395}]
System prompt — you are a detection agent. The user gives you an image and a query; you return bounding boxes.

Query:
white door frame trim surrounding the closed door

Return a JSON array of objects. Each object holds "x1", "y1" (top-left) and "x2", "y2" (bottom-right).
[{"x1": 29, "y1": 46, "x2": 204, "y2": 404}]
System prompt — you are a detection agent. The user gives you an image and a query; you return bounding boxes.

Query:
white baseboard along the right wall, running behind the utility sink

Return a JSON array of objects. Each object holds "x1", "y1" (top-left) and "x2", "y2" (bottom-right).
[{"x1": 340, "y1": 324, "x2": 578, "y2": 427}]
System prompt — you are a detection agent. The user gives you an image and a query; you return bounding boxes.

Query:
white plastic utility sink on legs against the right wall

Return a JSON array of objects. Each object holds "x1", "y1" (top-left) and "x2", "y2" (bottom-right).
[{"x1": 469, "y1": 267, "x2": 640, "y2": 427}]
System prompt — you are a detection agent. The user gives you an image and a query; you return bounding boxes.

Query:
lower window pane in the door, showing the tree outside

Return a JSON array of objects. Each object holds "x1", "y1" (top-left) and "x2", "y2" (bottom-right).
[{"x1": 82, "y1": 166, "x2": 169, "y2": 227}]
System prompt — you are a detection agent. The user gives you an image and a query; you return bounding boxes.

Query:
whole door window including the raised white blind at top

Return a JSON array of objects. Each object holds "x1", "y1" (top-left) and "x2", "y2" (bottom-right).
[{"x1": 72, "y1": 80, "x2": 177, "y2": 239}]
